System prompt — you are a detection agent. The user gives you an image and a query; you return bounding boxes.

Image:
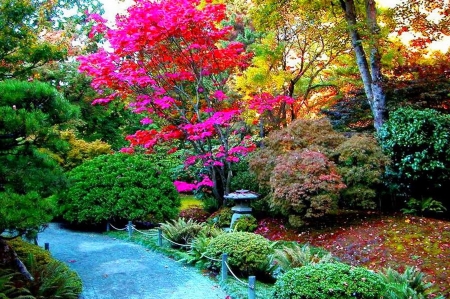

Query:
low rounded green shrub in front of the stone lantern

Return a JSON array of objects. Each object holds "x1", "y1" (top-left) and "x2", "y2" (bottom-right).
[{"x1": 206, "y1": 232, "x2": 273, "y2": 277}]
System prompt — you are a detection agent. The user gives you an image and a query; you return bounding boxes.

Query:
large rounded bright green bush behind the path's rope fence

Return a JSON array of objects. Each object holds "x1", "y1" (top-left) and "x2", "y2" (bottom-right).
[{"x1": 60, "y1": 154, "x2": 180, "y2": 223}]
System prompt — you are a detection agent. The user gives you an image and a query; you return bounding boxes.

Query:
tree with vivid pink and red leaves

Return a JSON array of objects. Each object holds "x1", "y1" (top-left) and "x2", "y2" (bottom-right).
[{"x1": 79, "y1": 0, "x2": 253, "y2": 199}]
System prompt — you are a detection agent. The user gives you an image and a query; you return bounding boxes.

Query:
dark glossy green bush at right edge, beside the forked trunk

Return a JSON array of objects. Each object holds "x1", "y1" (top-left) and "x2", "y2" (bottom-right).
[{"x1": 379, "y1": 108, "x2": 450, "y2": 204}]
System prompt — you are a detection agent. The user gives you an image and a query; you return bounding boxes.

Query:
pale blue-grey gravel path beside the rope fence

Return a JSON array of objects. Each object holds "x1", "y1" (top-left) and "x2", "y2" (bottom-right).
[{"x1": 39, "y1": 223, "x2": 226, "y2": 299}]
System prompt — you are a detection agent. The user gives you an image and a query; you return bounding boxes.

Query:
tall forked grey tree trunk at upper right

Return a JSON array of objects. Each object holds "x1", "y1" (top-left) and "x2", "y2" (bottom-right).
[{"x1": 340, "y1": 0, "x2": 386, "y2": 132}]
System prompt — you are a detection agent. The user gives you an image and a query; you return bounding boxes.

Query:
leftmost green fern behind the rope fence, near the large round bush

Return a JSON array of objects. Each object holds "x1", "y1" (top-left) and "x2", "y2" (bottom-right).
[{"x1": 161, "y1": 218, "x2": 205, "y2": 246}]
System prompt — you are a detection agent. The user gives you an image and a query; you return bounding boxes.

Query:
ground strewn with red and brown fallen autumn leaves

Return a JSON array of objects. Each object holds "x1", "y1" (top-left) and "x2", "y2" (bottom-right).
[{"x1": 257, "y1": 213, "x2": 450, "y2": 298}]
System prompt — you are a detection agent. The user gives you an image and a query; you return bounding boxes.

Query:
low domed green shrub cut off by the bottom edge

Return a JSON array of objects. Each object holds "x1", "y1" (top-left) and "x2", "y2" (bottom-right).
[{"x1": 272, "y1": 263, "x2": 385, "y2": 299}]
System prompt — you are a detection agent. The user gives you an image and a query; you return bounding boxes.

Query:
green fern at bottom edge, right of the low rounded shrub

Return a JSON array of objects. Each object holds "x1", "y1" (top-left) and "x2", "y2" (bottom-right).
[{"x1": 381, "y1": 267, "x2": 444, "y2": 299}]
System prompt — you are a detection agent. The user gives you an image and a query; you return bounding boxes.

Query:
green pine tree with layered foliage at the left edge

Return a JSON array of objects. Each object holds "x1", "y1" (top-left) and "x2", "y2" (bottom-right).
[{"x1": 0, "y1": 80, "x2": 78, "y2": 278}]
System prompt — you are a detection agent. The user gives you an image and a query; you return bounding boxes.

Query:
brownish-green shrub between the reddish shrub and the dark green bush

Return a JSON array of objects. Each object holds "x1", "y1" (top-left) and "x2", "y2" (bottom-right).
[{"x1": 336, "y1": 134, "x2": 389, "y2": 209}]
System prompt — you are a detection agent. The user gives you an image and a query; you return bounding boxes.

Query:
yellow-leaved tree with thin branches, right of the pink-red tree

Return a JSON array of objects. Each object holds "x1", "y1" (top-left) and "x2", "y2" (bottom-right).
[{"x1": 238, "y1": 0, "x2": 349, "y2": 131}]
